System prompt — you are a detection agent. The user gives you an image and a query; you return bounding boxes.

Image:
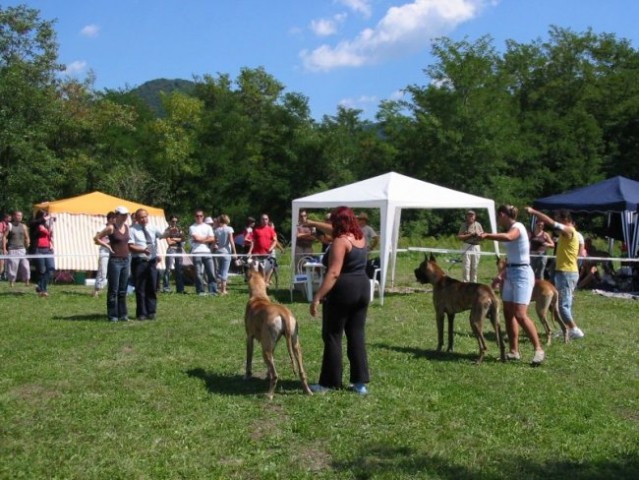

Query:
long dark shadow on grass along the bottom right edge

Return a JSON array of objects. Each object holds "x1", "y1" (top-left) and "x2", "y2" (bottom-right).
[{"x1": 333, "y1": 444, "x2": 639, "y2": 480}]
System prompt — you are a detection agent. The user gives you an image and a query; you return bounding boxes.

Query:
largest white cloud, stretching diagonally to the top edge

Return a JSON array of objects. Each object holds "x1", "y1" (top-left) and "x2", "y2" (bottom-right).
[{"x1": 300, "y1": 0, "x2": 487, "y2": 71}]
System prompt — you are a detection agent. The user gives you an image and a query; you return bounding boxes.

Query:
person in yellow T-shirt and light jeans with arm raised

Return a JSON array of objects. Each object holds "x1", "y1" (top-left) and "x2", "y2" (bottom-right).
[{"x1": 526, "y1": 207, "x2": 584, "y2": 340}]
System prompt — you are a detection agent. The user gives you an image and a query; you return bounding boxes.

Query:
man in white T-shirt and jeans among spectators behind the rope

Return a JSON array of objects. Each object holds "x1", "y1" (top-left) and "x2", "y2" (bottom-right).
[{"x1": 189, "y1": 210, "x2": 217, "y2": 296}]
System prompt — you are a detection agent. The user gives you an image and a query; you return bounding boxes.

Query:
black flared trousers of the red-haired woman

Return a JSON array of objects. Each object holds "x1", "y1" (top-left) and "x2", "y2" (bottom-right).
[{"x1": 319, "y1": 275, "x2": 370, "y2": 388}]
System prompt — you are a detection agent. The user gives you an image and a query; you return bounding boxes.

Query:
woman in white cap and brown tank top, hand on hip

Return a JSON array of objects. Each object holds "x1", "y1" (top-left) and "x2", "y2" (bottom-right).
[{"x1": 93, "y1": 206, "x2": 130, "y2": 322}]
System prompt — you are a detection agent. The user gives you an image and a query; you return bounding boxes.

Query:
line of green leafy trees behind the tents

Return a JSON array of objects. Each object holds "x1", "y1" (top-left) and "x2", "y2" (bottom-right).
[{"x1": 0, "y1": 5, "x2": 639, "y2": 239}]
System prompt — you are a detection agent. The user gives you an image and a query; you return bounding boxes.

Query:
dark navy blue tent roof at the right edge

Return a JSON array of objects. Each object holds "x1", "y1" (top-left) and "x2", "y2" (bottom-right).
[{"x1": 533, "y1": 176, "x2": 639, "y2": 212}]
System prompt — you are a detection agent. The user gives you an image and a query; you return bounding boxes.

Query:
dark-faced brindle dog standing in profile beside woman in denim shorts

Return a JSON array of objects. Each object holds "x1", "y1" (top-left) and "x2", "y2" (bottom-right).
[{"x1": 415, "y1": 254, "x2": 506, "y2": 363}]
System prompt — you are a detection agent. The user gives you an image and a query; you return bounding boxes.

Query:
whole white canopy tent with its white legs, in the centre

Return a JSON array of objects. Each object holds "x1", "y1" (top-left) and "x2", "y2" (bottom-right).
[{"x1": 291, "y1": 172, "x2": 498, "y2": 305}]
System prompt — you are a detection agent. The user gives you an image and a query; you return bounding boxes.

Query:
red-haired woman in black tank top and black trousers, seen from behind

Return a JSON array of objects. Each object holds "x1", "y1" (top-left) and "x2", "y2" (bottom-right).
[{"x1": 310, "y1": 207, "x2": 371, "y2": 395}]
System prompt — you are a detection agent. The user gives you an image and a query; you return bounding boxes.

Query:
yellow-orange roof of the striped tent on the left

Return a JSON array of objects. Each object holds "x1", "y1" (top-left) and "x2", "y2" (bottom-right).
[{"x1": 35, "y1": 192, "x2": 164, "y2": 217}]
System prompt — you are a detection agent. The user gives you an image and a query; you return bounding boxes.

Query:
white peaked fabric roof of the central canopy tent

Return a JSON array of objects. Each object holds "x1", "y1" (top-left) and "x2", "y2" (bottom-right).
[{"x1": 294, "y1": 172, "x2": 494, "y2": 208}]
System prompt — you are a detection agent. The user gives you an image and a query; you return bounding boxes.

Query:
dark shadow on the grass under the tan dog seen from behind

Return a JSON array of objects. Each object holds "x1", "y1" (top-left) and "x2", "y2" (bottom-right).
[{"x1": 185, "y1": 368, "x2": 303, "y2": 395}]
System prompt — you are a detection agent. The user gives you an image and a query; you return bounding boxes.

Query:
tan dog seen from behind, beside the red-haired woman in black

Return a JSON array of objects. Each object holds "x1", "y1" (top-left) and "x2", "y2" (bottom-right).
[{"x1": 244, "y1": 262, "x2": 313, "y2": 399}]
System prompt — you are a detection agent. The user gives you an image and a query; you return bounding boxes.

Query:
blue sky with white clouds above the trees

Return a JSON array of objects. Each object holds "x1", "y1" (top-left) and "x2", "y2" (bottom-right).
[{"x1": 2, "y1": 0, "x2": 639, "y2": 120}]
